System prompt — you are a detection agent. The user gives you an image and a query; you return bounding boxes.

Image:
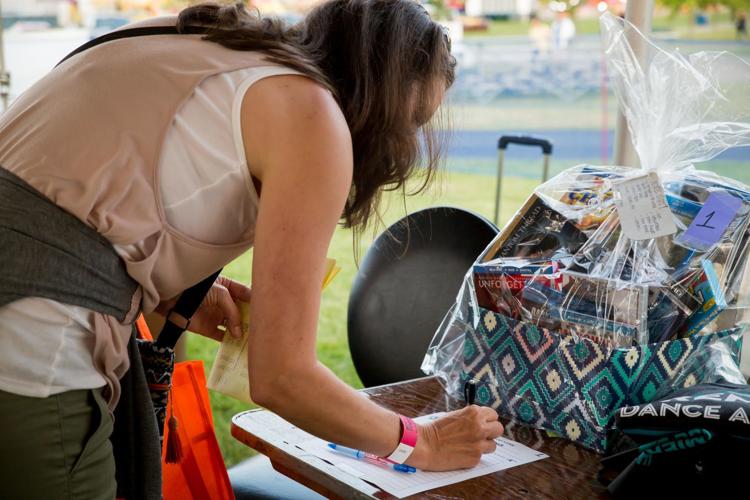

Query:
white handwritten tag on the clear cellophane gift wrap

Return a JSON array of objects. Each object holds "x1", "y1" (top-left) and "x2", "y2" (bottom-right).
[{"x1": 612, "y1": 172, "x2": 677, "y2": 240}]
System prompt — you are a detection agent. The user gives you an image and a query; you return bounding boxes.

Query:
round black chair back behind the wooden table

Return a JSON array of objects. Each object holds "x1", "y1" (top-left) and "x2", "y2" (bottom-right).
[{"x1": 348, "y1": 207, "x2": 498, "y2": 387}]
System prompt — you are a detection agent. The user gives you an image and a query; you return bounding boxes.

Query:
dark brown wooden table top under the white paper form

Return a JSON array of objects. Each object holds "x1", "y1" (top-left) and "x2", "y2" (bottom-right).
[{"x1": 232, "y1": 377, "x2": 607, "y2": 499}]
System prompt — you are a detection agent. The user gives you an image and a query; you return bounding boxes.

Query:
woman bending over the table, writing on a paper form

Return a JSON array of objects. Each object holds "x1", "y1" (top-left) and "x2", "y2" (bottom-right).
[{"x1": 0, "y1": 0, "x2": 503, "y2": 499}]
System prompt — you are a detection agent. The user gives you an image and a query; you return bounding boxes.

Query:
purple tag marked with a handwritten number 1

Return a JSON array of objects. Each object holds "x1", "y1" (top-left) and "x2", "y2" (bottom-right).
[{"x1": 678, "y1": 191, "x2": 742, "y2": 252}]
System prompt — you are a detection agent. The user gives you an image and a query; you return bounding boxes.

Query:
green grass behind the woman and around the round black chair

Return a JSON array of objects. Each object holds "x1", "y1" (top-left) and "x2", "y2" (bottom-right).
[{"x1": 188, "y1": 173, "x2": 536, "y2": 466}]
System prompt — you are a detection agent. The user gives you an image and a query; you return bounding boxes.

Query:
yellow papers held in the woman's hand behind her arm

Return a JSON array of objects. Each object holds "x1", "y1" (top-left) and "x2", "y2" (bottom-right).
[{"x1": 206, "y1": 259, "x2": 341, "y2": 403}]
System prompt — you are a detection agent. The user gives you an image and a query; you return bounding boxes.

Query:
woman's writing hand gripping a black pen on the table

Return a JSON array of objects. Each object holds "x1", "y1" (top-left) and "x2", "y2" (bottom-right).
[{"x1": 406, "y1": 405, "x2": 503, "y2": 471}]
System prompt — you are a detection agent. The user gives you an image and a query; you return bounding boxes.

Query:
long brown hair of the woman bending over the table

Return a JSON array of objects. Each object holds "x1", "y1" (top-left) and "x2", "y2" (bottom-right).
[{"x1": 178, "y1": 0, "x2": 455, "y2": 232}]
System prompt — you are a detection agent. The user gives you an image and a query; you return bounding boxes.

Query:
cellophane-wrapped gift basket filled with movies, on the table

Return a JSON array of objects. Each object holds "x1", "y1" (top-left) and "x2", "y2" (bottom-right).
[{"x1": 422, "y1": 14, "x2": 750, "y2": 452}]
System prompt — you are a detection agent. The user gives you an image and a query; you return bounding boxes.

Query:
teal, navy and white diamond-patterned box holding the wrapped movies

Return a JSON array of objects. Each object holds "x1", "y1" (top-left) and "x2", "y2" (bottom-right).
[{"x1": 461, "y1": 308, "x2": 741, "y2": 453}]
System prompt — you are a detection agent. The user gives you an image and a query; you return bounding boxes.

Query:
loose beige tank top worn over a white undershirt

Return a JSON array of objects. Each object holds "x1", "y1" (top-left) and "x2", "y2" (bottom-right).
[{"x1": 0, "y1": 25, "x2": 288, "y2": 404}]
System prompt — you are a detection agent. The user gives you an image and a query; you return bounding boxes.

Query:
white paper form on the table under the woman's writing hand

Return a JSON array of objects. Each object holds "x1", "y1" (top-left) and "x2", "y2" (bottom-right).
[{"x1": 295, "y1": 413, "x2": 548, "y2": 498}]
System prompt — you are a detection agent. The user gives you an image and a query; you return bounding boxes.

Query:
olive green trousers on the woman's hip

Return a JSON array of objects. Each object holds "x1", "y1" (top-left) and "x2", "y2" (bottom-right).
[{"x1": 0, "y1": 389, "x2": 116, "y2": 500}]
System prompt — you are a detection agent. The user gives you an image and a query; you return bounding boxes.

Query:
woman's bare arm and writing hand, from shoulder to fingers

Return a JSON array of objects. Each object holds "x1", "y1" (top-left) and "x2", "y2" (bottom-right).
[{"x1": 242, "y1": 76, "x2": 502, "y2": 470}]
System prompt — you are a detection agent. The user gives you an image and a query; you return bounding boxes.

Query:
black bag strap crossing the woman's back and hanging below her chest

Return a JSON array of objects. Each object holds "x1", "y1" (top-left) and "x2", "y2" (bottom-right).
[{"x1": 57, "y1": 26, "x2": 221, "y2": 348}]
